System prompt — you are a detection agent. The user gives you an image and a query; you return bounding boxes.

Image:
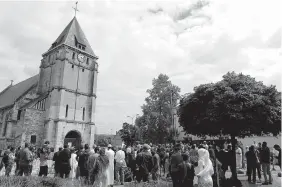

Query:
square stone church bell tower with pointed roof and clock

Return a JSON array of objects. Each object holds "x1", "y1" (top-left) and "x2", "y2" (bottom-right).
[{"x1": 37, "y1": 17, "x2": 98, "y2": 150}]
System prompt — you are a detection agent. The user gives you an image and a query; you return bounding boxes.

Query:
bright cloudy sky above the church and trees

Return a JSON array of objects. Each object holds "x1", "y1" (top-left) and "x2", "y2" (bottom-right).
[{"x1": 0, "y1": 0, "x2": 282, "y2": 134}]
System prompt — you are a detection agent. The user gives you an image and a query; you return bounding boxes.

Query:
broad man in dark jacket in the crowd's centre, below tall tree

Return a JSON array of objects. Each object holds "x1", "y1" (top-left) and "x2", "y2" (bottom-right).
[{"x1": 136, "y1": 144, "x2": 153, "y2": 182}]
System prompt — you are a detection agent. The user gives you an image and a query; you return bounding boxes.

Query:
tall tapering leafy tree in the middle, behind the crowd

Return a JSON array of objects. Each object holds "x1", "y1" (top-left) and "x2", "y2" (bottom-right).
[{"x1": 136, "y1": 74, "x2": 180, "y2": 143}]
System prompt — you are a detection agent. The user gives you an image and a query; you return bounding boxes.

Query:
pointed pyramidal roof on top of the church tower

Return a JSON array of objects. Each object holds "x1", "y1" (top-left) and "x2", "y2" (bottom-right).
[{"x1": 49, "y1": 17, "x2": 96, "y2": 56}]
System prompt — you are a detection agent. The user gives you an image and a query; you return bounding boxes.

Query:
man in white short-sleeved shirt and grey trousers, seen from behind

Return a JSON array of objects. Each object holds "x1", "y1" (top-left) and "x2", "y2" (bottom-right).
[{"x1": 115, "y1": 147, "x2": 126, "y2": 185}]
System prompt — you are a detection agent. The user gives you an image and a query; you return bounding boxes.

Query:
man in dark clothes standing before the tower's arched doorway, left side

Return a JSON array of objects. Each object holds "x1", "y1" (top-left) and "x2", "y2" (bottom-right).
[{"x1": 58, "y1": 144, "x2": 71, "y2": 178}]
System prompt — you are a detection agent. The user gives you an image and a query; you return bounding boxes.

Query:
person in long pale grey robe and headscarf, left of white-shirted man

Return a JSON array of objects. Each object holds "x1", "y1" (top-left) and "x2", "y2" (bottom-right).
[{"x1": 94, "y1": 148, "x2": 109, "y2": 187}]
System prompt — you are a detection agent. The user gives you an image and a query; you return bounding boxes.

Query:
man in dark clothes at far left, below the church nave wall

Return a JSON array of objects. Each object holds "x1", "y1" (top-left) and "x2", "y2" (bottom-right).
[{"x1": 18, "y1": 143, "x2": 32, "y2": 176}]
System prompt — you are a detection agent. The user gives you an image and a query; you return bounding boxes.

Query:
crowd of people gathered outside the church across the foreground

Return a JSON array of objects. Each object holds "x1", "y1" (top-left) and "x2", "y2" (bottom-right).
[{"x1": 0, "y1": 141, "x2": 281, "y2": 187}]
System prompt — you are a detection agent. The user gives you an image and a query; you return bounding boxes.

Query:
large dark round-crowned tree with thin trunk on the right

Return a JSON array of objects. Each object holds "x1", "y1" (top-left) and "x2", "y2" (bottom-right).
[{"x1": 178, "y1": 72, "x2": 281, "y2": 183}]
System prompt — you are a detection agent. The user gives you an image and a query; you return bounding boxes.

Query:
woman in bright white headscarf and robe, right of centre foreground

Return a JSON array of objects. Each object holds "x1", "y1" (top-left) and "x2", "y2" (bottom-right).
[{"x1": 197, "y1": 148, "x2": 214, "y2": 187}]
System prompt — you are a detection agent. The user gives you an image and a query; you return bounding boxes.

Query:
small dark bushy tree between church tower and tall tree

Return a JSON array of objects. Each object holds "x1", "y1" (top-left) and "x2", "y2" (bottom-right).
[{"x1": 118, "y1": 123, "x2": 139, "y2": 146}]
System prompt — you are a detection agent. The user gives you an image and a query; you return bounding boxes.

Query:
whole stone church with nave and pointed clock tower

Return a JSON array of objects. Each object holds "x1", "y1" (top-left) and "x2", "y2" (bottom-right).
[{"x1": 0, "y1": 17, "x2": 98, "y2": 150}]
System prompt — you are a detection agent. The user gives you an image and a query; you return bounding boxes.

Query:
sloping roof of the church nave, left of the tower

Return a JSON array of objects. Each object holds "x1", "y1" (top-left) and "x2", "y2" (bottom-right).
[{"x1": 0, "y1": 75, "x2": 39, "y2": 109}]
